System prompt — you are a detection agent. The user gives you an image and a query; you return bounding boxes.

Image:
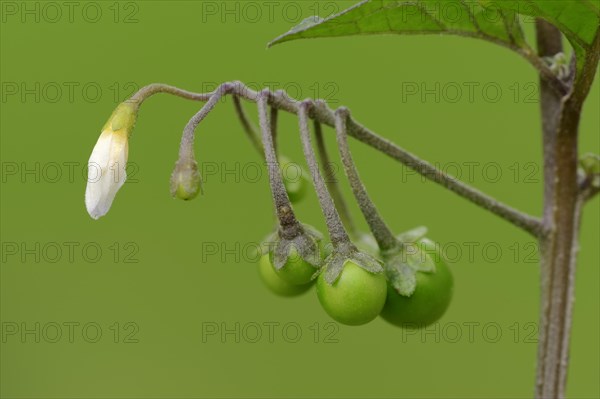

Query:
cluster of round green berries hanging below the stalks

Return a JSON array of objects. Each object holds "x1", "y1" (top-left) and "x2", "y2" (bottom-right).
[{"x1": 258, "y1": 180, "x2": 453, "y2": 328}]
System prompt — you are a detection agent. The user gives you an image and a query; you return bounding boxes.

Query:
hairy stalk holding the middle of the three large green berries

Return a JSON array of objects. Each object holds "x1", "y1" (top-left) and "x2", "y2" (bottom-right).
[{"x1": 298, "y1": 101, "x2": 350, "y2": 248}]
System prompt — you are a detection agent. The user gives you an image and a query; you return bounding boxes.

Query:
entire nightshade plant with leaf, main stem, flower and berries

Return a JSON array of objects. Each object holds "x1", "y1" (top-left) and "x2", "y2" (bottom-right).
[{"x1": 85, "y1": 0, "x2": 600, "y2": 398}]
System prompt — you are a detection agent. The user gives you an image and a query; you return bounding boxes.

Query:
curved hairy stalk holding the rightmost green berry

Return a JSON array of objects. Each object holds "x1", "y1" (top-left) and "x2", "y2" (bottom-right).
[{"x1": 335, "y1": 107, "x2": 399, "y2": 252}]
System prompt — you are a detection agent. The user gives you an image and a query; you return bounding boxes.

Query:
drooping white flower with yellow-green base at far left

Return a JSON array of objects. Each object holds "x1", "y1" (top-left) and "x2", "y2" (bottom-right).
[{"x1": 85, "y1": 103, "x2": 137, "y2": 219}]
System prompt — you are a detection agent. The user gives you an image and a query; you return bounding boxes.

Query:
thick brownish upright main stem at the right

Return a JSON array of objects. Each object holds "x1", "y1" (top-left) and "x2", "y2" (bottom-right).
[{"x1": 535, "y1": 20, "x2": 600, "y2": 398}]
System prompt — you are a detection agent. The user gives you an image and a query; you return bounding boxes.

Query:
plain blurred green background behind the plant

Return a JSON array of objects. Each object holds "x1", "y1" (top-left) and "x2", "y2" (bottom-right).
[{"x1": 0, "y1": 1, "x2": 600, "y2": 398}]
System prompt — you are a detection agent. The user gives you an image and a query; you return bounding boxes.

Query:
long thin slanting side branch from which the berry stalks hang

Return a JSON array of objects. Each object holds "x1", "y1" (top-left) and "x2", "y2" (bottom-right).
[{"x1": 134, "y1": 82, "x2": 542, "y2": 237}]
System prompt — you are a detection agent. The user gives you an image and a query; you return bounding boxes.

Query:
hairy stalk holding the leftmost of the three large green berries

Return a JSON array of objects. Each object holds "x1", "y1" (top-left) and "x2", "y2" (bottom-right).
[{"x1": 257, "y1": 91, "x2": 301, "y2": 238}]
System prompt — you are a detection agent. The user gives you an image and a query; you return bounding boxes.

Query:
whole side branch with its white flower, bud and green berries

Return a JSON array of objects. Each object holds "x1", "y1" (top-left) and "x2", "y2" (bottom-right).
[{"x1": 86, "y1": 82, "x2": 598, "y2": 327}]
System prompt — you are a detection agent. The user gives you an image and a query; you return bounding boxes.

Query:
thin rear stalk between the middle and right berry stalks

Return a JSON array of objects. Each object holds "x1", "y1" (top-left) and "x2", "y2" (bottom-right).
[{"x1": 313, "y1": 115, "x2": 358, "y2": 241}]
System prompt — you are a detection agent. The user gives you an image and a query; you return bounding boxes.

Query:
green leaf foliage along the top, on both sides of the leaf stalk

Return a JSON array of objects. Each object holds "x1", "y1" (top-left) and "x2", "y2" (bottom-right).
[{"x1": 269, "y1": 0, "x2": 600, "y2": 71}]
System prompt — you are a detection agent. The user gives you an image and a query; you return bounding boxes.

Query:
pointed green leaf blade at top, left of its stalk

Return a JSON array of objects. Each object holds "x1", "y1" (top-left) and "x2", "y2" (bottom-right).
[{"x1": 269, "y1": 0, "x2": 526, "y2": 48}]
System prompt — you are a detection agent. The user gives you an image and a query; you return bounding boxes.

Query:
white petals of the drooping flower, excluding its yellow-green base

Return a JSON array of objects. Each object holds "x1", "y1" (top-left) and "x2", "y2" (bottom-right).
[{"x1": 85, "y1": 130, "x2": 129, "y2": 219}]
